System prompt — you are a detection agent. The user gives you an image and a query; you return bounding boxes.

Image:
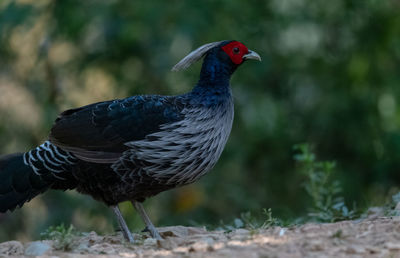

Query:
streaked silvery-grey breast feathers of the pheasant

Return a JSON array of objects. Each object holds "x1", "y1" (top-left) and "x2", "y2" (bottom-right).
[{"x1": 127, "y1": 99, "x2": 234, "y2": 185}]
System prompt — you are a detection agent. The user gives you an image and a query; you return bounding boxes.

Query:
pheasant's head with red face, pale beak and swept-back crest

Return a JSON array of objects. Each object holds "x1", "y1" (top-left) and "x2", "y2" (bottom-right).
[{"x1": 172, "y1": 40, "x2": 261, "y2": 72}]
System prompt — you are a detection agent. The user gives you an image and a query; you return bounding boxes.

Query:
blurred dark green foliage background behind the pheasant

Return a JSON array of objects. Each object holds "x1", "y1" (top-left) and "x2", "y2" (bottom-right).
[{"x1": 0, "y1": 0, "x2": 400, "y2": 241}]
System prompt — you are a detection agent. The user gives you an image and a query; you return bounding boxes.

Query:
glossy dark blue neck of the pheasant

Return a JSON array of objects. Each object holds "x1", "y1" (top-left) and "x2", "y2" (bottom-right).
[{"x1": 191, "y1": 56, "x2": 235, "y2": 105}]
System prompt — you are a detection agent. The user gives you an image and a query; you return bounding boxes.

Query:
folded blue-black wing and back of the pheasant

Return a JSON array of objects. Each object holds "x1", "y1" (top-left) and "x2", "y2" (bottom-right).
[{"x1": 49, "y1": 95, "x2": 183, "y2": 163}]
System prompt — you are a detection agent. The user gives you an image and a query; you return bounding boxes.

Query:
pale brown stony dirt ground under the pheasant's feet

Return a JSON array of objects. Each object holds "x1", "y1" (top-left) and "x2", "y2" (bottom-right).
[{"x1": 0, "y1": 217, "x2": 400, "y2": 258}]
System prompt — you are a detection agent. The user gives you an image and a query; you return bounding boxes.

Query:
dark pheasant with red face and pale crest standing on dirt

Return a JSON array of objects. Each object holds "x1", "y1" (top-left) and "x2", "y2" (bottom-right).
[{"x1": 0, "y1": 40, "x2": 261, "y2": 242}]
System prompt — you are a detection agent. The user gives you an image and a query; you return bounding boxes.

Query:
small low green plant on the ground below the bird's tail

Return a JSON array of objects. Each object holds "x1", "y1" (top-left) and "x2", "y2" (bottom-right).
[{"x1": 40, "y1": 223, "x2": 81, "y2": 251}]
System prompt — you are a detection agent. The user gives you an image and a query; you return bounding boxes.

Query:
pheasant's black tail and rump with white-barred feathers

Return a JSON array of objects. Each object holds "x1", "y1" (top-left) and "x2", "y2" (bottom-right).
[{"x1": 0, "y1": 142, "x2": 78, "y2": 213}]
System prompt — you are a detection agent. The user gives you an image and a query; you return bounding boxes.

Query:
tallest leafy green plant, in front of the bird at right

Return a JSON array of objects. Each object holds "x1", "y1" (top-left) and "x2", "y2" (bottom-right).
[{"x1": 294, "y1": 144, "x2": 356, "y2": 222}]
